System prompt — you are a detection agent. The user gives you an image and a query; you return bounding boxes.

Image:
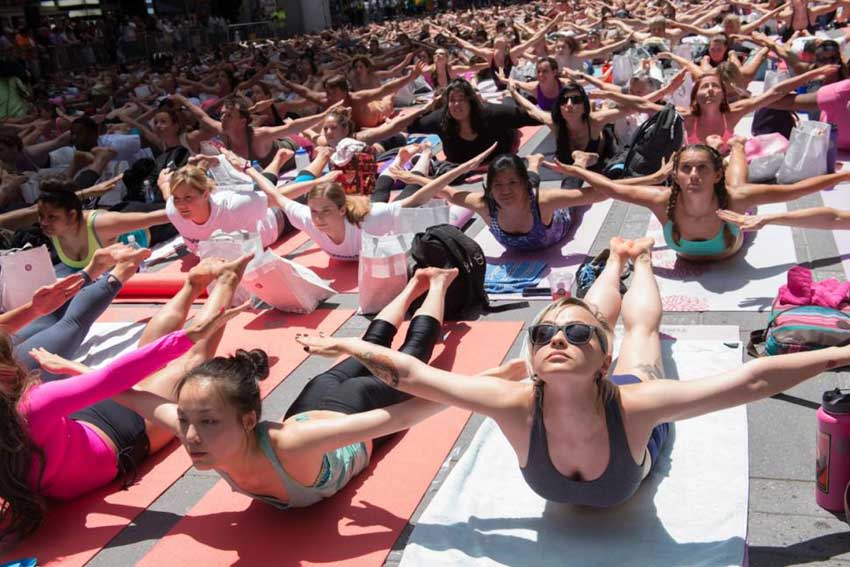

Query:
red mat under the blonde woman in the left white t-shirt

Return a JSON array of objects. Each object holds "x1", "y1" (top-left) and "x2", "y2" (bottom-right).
[{"x1": 115, "y1": 231, "x2": 310, "y2": 303}]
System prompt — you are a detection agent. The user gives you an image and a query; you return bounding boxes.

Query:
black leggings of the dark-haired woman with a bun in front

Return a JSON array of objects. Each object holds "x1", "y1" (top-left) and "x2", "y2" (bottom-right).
[{"x1": 286, "y1": 315, "x2": 440, "y2": 418}]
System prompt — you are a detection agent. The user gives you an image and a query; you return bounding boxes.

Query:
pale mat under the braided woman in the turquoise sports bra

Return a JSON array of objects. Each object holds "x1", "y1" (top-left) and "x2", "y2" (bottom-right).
[{"x1": 647, "y1": 203, "x2": 797, "y2": 311}]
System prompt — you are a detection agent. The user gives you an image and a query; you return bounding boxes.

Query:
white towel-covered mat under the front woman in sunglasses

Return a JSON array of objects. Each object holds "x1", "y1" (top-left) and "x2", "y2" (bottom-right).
[{"x1": 401, "y1": 326, "x2": 749, "y2": 567}]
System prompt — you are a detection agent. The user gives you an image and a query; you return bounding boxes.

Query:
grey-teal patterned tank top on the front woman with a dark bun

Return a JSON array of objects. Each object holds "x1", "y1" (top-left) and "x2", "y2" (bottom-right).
[{"x1": 217, "y1": 415, "x2": 369, "y2": 510}]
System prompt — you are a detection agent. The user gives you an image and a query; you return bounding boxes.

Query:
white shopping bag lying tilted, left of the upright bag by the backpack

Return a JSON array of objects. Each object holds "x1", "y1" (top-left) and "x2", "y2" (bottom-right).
[{"x1": 242, "y1": 251, "x2": 336, "y2": 313}]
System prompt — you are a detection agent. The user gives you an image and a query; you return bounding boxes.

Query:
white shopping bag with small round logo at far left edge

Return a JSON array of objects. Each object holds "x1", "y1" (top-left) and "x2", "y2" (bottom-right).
[{"x1": 0, "y1": 245, "x2": 56, "y2": 311}]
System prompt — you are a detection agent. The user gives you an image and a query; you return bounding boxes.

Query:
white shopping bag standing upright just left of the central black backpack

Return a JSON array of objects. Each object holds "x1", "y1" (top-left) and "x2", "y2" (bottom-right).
[{"x1": 357, "y1": 232, "x2": 413, "y2": 313}]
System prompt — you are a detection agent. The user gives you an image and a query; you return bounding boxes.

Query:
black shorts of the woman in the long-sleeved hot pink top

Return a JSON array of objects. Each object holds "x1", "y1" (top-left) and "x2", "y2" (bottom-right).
[{"x1": 70, "y1": 400, "x2": 151, "y2": 488}]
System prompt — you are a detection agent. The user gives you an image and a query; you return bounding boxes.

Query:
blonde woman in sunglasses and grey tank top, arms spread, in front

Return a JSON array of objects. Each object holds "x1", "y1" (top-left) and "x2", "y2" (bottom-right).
[{"x1": 297, "y1": 233, "x2": 850, "y2": 507}]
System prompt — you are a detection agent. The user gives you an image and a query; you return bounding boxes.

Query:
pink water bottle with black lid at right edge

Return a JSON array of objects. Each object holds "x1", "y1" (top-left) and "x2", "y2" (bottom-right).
[{"x1": 815, "y1": 388, "x2": 850, "y2": 512}]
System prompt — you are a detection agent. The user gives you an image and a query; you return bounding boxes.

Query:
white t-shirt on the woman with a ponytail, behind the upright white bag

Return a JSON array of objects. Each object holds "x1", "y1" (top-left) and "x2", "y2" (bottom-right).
[{"x1": 283, "y1": 201, "x2": 401, "y2": 261}]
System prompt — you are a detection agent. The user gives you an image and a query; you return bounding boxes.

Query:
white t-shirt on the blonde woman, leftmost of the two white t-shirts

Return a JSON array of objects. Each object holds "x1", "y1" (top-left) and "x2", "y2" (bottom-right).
[{"x1": 165, "y1": 189, "x2": 280, "y2": 252}]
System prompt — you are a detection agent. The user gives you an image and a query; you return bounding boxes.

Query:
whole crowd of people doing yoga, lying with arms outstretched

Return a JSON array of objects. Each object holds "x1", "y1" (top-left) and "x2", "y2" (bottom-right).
[{"x1": 0, "y1": 0, "x2": 850, "y2": 556}]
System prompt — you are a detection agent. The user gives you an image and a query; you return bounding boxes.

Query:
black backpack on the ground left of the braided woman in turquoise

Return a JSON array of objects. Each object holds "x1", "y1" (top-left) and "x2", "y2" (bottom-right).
[{"x1": 603, "y1": 104, "x2": 685, "y2": 179}]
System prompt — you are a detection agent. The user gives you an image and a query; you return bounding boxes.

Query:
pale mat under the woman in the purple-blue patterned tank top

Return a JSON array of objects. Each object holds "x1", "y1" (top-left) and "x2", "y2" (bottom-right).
[{"x1": 475, "y1": 200, "x2": 611, "y2": 301}]
